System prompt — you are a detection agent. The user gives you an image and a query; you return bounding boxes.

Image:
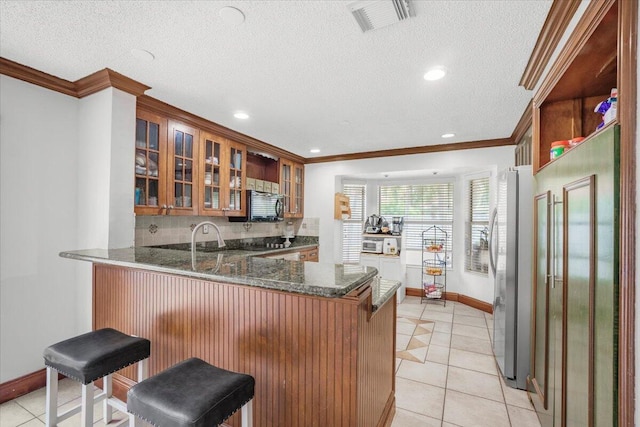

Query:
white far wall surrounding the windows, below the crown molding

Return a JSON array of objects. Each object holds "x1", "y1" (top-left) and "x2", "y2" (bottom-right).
[{"x1": 304, "y1": 146, "x2": 514, "y2": 302}]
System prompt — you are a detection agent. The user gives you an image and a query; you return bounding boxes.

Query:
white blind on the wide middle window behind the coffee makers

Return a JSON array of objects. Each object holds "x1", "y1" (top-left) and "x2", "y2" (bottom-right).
[{"x1": 378, "y1": 182, "x2": 453, "y2": 260}]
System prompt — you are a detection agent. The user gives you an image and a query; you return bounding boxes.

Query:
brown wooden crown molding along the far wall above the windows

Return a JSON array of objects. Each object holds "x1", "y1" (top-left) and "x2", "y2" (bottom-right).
[{"x1": 305, "y1": 138, "x2": 515, "y2": 163}]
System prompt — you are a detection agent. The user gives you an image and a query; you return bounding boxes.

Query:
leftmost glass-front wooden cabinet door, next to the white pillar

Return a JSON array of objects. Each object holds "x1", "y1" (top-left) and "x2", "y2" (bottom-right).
[{"x1": 134, "y1": 111, "x2": 168, "y2": 215}]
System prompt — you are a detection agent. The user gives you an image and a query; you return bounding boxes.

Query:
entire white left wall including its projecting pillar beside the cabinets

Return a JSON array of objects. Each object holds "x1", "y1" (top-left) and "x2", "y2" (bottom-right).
[{"x1": 0, "y1": 75, "x2": 136, "y2": 383}]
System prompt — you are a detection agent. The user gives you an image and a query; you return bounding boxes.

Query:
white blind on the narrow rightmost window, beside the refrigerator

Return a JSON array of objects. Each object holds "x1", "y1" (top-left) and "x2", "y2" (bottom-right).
[{"x1": 465, "y1": 177, "x2": 489, "y2": 274}]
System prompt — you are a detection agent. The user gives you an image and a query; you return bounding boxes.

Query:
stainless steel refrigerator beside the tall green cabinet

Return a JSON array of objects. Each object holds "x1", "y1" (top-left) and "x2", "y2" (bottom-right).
[{"x1": 489, "y1": 166, "x2": 533, "y2": 390}]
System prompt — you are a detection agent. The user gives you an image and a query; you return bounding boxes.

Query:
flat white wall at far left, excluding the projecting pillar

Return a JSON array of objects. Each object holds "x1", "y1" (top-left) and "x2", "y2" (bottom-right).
[{"x1": 0, "y1": 75, "x2": 78, "y2": 382}]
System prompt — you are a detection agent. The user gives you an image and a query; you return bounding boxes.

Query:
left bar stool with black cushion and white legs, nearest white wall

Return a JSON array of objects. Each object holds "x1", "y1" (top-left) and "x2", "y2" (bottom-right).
[{"x1": 44, "y1": 328, "x2": 151, "y2": 426}]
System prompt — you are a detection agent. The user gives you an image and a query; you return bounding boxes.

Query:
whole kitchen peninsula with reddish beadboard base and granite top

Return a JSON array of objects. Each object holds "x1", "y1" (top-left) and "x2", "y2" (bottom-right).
[{"x1": 60, "y1": 247, "x2": 399, "y2": 427}]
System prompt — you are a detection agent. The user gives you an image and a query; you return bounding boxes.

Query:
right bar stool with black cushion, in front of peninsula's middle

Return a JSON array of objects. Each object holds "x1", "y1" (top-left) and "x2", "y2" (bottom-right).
[{"x1": 127, "y1": 357, "x2": 255, "y2": 427}]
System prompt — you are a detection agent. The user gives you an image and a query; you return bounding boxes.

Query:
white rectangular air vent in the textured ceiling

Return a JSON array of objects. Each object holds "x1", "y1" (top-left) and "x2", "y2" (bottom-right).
[{"x1": 347, "y1": 0, "x2": 415, "y2": 33}]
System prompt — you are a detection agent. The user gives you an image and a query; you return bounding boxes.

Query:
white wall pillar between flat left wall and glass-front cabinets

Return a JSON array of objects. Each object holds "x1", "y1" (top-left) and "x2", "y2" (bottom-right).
[{"x1": 75, "y1": 88, "x2": 136, "y2": 332}]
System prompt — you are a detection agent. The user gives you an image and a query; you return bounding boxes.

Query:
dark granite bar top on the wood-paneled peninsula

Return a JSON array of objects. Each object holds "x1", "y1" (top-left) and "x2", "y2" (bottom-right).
[{"x1": 60, "y1": 245, "x2": 395, "y2": 300}]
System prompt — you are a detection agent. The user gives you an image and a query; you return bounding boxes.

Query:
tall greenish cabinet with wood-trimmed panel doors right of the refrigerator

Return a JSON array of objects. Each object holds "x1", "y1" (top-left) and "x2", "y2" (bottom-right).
[{"x1": 529, "y1": 126, "x2": 619, "y2": 427}]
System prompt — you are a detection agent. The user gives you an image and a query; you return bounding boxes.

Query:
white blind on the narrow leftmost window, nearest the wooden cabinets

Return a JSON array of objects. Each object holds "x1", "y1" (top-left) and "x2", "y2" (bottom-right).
[{"x1": 342, "y1": 184, "x2": 366, "y2": 264}]
